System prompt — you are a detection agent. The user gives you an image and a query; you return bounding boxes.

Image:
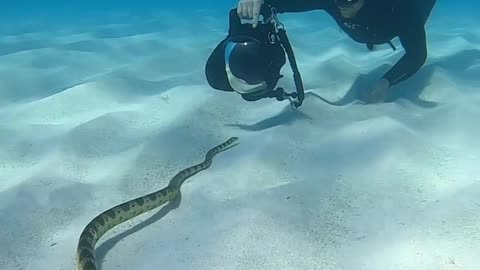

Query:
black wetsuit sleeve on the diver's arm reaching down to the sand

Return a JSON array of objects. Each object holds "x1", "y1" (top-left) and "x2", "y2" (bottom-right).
[{"x1": 383, "y1": 15, "x2": 427, "y2": 85}]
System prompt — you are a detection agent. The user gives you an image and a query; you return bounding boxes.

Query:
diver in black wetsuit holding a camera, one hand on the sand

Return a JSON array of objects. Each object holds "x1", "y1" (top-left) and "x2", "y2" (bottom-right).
[{"x1": 236, "y1": 0, "x2": 436, "y2": 103}]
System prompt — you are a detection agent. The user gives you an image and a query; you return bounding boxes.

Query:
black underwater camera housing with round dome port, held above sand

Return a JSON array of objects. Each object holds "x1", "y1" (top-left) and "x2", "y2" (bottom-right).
[{"x1": 205, "y1": 5, "x2": 304, "y2": 109}]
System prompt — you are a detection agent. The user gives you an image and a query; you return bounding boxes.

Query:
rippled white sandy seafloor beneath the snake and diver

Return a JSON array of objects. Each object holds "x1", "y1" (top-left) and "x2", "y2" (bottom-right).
[{"x1": 0, "y1": 5, "x2": 480, "y2": 270}]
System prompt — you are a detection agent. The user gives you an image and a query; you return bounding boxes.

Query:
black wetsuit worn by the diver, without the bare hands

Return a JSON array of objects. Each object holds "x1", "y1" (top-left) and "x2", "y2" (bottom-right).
[{"x1": 265, "y1": 0, "x2": 436, "y2": 85}]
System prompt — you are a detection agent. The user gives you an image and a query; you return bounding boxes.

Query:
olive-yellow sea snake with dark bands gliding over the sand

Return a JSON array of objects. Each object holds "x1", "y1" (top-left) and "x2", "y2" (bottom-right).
[{"x1": 77, "y1": 137, "x2": 238, "y2": 270}]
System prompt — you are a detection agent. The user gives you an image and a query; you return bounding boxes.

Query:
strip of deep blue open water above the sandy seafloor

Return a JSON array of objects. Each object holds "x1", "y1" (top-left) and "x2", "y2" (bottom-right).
[{"x1": 0, "y1": 0, "x2": 474, "y2": 22}]
